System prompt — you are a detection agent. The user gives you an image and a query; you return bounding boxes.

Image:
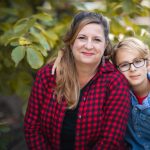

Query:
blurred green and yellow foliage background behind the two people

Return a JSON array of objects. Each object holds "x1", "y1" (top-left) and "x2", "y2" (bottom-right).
[{"x1": 0, "y1": 0, "x2": 150, "y2": 150}]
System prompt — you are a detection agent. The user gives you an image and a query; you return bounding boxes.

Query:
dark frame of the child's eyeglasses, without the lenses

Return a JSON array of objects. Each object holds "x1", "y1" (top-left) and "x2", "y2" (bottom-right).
[{"x1": 117, "y1": 58, "x2": 148, "y2": 72}]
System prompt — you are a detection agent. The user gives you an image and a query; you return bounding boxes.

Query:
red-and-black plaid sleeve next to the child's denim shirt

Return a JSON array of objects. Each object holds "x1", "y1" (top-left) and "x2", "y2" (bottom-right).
[{"x1": 94, "y1": 73, "x2": 130, "y2": 150}]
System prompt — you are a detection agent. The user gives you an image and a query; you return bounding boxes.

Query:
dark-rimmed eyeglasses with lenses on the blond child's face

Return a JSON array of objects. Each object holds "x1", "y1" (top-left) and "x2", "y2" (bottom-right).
[{"x1": 117, "y1": 58, "x2": 147, "y2": 72}]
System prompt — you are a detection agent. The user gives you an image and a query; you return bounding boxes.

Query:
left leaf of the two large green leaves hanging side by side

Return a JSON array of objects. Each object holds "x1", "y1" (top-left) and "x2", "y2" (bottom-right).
[{"x1": 11, "y1": 46, "x2": 25, "y2": 66}]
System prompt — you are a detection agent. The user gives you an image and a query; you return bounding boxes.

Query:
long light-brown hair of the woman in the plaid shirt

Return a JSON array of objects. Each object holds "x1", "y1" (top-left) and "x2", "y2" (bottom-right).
[{"x1": 49, "y1": 12, "x2": 111, "y2": 109}]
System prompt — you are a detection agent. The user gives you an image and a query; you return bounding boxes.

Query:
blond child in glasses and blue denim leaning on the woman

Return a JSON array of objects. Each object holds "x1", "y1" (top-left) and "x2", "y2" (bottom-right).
[{"x1": 112, "y1": 37, "x2": 150, "y2": 150}]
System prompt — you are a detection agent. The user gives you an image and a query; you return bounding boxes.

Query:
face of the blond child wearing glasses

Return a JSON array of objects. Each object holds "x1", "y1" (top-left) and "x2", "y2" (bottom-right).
[{"x1": 116, "y1": 50, "x2": 147, "y2": 88}]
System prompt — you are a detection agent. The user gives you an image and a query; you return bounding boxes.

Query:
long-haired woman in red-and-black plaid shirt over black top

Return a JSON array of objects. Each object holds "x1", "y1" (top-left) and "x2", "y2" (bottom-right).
[{"x1": 24, "y1": 12, "x2": 130, "y2": 150}]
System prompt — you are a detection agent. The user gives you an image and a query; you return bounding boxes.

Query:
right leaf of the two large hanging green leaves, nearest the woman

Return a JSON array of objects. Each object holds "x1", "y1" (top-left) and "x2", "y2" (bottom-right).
[{"x1": 27, "y1": 47, "x2": 44, "y2": 69}]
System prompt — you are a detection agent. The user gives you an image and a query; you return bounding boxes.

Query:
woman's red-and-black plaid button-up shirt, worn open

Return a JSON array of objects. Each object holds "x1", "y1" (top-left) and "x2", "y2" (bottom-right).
[{"x1": 24, "y1": 62, "x2": 130, "y2": 150}]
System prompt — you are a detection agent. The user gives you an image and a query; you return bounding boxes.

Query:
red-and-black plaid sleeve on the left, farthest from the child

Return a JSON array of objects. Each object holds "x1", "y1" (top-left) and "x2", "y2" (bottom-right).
[{"x1": 24, "y1": 67, "x2": 51, "y2": 150}]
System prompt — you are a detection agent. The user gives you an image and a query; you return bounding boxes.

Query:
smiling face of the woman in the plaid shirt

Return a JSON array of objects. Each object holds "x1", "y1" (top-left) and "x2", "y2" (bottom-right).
[{"x1": 71, "y1": 23, "x2": 106, "y2": 66}]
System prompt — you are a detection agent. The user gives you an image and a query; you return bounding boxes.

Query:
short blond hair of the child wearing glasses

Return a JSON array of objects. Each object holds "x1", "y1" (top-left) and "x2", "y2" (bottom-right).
[{"x1": 111, "y1": 37, "x2": 150, "y2": 65}]
